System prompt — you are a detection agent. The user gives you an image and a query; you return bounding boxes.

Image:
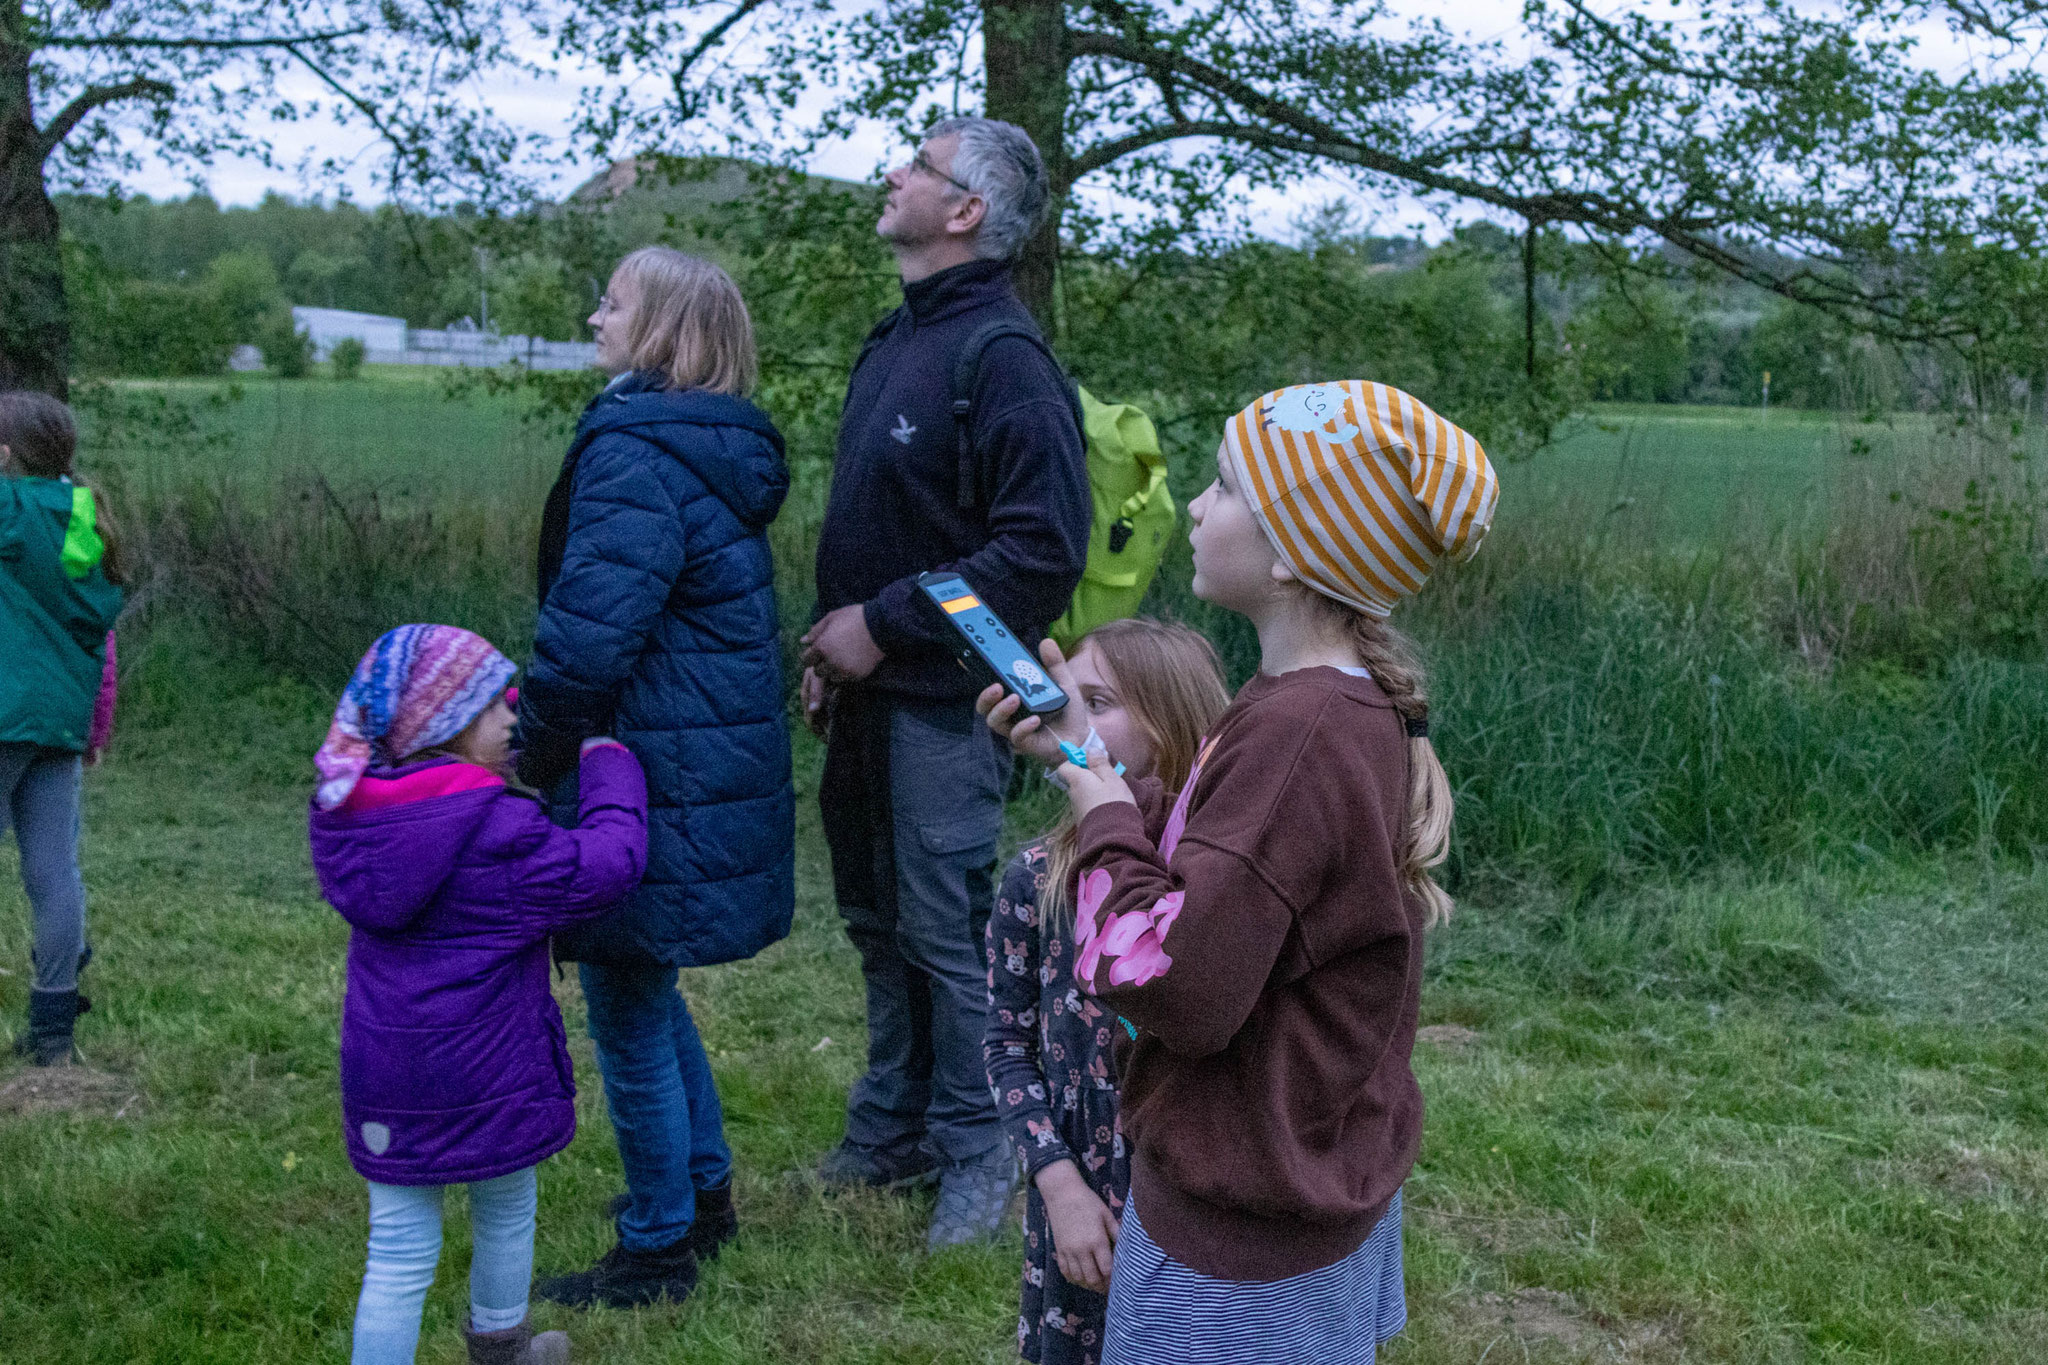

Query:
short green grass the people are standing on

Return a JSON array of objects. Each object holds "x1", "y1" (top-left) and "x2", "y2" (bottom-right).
[{"x1": 0, "y1": 694, "x2": 2048, "y2": 1365}]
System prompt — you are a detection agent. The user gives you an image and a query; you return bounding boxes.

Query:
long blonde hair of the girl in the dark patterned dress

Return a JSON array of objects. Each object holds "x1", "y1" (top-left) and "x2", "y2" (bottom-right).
[{"x1": 1038, "y1": 616, "x2": 1231, "y2": 929}]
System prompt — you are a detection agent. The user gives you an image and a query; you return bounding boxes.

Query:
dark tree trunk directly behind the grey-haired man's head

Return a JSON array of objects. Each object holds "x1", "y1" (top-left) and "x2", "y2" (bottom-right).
[{"x1": 981, "y1": 0, "x2": 1071, "y2": 336}]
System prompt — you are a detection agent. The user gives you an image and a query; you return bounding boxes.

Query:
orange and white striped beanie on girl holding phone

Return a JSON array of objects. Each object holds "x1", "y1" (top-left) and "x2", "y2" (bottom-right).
[{"x1": 1223, "y1": 379, "x2": 1501, "y2": 616}]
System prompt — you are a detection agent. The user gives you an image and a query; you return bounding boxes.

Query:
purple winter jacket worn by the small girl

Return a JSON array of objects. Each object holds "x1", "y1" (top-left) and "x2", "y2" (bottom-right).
[{"x1": 311, "y1": 745, "x2": 647, "y2": 1185}]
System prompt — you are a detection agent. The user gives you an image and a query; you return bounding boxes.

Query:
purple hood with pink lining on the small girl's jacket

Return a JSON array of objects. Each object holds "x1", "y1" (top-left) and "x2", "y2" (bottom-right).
[{"x1": 311, "y1": 759, "x2": 506, "y2": 933}]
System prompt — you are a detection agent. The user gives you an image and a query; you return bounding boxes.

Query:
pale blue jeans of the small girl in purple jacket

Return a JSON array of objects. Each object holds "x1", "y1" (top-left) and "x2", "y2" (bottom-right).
[{"x1": 348, "y1": 1166, "x2": 539, "y2": 1365}]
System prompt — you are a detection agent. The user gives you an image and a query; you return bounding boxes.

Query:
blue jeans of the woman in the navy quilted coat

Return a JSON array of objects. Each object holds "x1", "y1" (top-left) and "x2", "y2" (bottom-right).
[{"x1": 582, "y1": 962, "x2": 733, "y2": 1250}]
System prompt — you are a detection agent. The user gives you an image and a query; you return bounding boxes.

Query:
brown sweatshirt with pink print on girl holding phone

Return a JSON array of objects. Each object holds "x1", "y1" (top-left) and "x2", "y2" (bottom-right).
[{"x1": 1075, "y1": 667, "x2": 1423, "y2": 1281}]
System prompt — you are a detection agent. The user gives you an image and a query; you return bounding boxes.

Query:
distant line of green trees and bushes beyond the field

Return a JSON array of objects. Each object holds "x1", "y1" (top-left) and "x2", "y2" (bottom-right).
[{"x1": 57, "y1": 186, "x2": 1944, "y2": 432}]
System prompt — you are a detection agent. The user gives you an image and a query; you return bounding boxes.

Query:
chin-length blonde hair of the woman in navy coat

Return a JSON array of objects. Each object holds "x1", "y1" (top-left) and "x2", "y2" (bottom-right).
[{"x1": 618, "y1": 246, "x2": 760, "y2": 397}]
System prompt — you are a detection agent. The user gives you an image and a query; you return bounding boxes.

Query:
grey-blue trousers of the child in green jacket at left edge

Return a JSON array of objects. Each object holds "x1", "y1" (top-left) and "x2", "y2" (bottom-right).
[{"x1": 0, "y1": 745, "x2": 86, "y2": 990}]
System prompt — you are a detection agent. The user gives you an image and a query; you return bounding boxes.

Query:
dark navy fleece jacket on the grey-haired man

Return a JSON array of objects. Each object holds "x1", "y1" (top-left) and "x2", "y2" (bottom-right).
[{"x1": 817, "y1": 262, "x2": 1094, "y2": 700}]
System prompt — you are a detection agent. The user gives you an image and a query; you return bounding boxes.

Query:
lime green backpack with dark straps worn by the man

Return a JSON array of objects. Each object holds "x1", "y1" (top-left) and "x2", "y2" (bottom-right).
[{"x1": 937, "y1": 319, "x2": 1178, "y2": 651}]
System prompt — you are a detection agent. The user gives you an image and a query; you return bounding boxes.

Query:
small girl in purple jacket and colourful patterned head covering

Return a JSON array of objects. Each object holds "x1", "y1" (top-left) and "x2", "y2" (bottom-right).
[{"x1": 311, "y1": 626, "x2": 647, "y2": 1365}]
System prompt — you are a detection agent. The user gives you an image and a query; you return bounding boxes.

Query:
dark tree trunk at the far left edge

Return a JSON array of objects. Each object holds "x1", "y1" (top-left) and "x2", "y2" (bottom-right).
[{"x1": 0, "y1": 14, "x2": 72, "y2": 399}]
